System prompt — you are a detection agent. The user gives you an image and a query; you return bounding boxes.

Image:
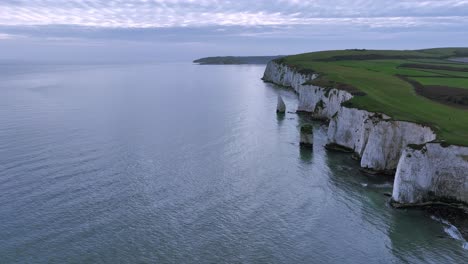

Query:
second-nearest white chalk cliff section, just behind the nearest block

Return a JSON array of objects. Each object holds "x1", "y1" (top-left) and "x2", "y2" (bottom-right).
[{"x1": 328, "y1": 107, "x2": 436, "y2": 173}]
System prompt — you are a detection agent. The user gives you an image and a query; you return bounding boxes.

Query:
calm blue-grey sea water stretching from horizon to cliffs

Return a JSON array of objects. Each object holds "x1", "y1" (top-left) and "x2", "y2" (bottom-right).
[{"x1": 0, "y1": 64, "x2": 468, "y2": 263}]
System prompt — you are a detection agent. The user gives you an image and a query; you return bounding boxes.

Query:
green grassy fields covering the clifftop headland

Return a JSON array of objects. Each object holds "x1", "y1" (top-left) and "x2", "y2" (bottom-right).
[{"x1": 276, "y1": 48, "x2": 468, "y2": 146}]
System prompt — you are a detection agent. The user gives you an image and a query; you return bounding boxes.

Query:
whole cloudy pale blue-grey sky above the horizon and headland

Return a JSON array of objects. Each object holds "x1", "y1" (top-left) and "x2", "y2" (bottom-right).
[{"x1": 0, "y1": 0, "x2": 468, "y2": 62}]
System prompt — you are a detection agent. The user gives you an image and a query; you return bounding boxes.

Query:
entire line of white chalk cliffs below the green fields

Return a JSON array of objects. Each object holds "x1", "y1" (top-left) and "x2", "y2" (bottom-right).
[{"x1": 263, "y1": 61, "x2": 468, "y2": 204}]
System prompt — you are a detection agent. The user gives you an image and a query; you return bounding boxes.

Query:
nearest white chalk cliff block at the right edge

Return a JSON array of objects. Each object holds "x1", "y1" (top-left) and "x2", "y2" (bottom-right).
[{"x1": 392, "y1": 143, "x2": 468, "y2": 204}]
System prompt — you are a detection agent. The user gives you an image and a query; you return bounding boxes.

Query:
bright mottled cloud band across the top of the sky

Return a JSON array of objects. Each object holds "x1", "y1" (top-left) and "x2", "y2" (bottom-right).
[{"x1": 0, "y1": 0, "x2": 468, "y2": 28}]
